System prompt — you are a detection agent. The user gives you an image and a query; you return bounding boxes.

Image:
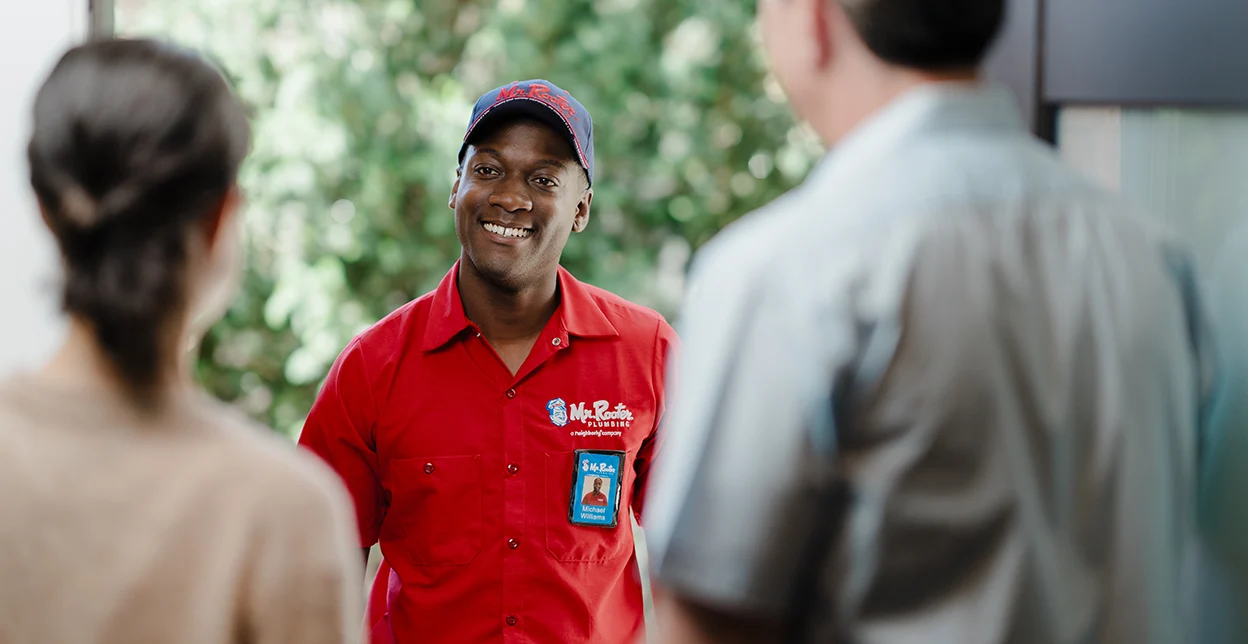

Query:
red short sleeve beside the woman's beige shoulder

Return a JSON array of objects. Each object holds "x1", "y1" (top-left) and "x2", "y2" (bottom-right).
[{"x1": 300, "y1": 339, "x2": 386, "y2": 548}]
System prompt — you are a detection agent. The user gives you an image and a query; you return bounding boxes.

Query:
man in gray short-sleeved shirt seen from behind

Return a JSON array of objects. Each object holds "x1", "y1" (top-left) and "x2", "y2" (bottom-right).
[{"x1": 645, "y1": 0, "x2": 1212, "y2": 644}]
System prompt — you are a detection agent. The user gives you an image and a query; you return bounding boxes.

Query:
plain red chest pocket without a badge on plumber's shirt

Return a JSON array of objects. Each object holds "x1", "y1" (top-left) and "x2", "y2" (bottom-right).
[{"x1": 389, "y1": 456, "x2": 482, "y2": 565}]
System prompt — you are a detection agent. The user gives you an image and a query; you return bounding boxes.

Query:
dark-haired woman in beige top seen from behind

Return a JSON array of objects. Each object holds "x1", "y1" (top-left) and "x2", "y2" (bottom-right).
[{"x1": 0, "y1": 40, "x2": 362, "y2": 644}]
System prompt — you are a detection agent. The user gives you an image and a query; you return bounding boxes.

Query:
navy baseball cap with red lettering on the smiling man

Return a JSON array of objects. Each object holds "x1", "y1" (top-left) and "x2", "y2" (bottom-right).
[{"x1": 459, "y1": 79, "x2": 594, "y2": 185}]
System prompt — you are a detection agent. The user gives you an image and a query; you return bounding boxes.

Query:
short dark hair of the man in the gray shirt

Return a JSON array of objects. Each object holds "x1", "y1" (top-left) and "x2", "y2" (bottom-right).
[{"x1": 829, "y1": 0, "x2": 1006, "y2": 71}]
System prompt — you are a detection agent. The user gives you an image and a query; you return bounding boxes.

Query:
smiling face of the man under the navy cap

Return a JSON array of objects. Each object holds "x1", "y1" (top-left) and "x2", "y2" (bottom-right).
[{"x1": 451, "y1": 120, "x2": 593, "y2": 290}]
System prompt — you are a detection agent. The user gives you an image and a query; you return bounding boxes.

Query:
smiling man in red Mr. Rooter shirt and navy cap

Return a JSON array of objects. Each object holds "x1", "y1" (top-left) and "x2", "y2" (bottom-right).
[{"x1": 300, "y1": 80, "x2": 675, "y2": 644}]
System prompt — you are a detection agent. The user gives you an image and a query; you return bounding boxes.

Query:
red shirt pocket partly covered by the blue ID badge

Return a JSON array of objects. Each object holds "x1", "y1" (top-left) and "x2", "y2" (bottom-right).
[{"x1": 542, "y1": 452, "x2": 633, "y2": 562}]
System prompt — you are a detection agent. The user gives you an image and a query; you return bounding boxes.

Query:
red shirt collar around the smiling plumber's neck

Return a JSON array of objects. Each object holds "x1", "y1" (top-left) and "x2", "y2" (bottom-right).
[{"x1": 421, "y1": 261, "x2": 619, "y2": 351}]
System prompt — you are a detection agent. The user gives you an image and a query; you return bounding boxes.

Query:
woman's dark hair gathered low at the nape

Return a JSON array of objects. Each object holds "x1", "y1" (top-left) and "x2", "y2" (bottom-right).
[{"x1": 26, "y1": 40, "x2": 251, "y2": 402}]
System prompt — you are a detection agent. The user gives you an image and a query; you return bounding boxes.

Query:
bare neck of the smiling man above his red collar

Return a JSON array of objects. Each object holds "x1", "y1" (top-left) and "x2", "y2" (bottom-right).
[{"x1": 457, "y1": 261, "x2": 559, "y2": 343}]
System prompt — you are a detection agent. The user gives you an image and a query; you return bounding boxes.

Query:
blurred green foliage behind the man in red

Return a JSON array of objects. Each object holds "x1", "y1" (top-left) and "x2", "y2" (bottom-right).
[{"x1": 116, "y1": 0, "x2": 819, "y2": 436}]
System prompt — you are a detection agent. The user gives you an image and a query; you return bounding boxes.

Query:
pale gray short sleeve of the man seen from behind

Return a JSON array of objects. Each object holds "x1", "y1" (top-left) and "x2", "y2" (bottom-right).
[{"x1": 646, "y1": 234, "x2": 852, "y2": 614}]
